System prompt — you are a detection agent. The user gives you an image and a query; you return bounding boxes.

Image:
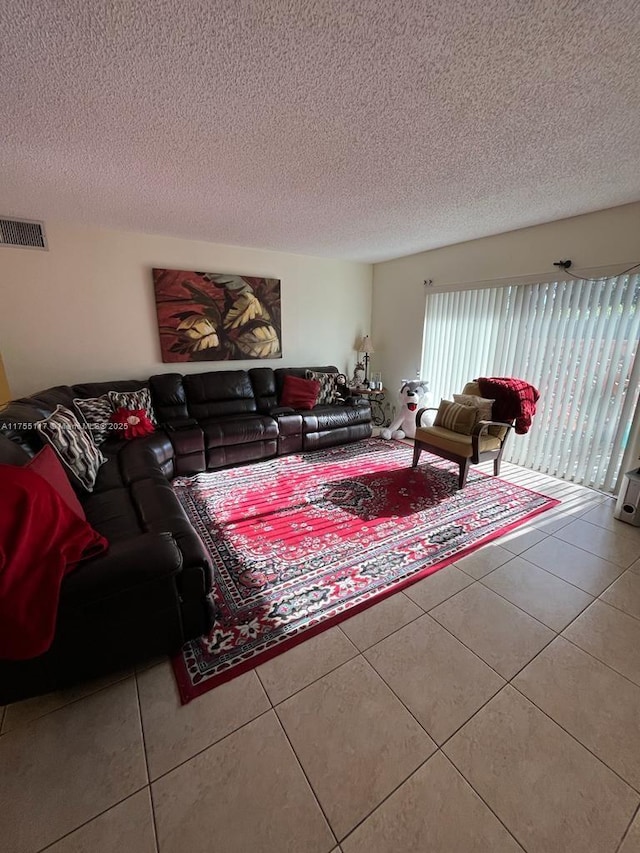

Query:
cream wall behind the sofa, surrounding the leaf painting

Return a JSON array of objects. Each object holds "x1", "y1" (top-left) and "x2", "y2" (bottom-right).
[{"x1": 0, "y1": 222, "x2": 372, "y2": 397}]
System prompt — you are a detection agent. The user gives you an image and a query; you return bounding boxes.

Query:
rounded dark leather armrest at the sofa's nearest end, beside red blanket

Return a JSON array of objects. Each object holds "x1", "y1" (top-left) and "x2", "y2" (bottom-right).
[{"x1": 60, "y1": 533, "x2": 183, "y2": 612}]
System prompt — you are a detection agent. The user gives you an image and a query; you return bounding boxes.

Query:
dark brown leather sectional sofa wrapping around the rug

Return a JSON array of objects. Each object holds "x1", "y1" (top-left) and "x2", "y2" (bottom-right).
[{"x1": 0, "y1": 366, "x2": 371, "y2": 704}]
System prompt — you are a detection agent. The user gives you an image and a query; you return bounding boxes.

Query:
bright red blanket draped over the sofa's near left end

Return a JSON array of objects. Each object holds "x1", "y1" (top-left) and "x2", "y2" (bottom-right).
[{"x1": 0, "y1": 465, "x2": 108, "y2": 660}]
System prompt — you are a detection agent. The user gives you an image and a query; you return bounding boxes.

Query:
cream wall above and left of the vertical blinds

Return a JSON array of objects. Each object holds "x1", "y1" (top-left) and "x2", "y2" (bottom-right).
[{"x1": 372, "y1": 202, "x2": 640, "y2": 392}]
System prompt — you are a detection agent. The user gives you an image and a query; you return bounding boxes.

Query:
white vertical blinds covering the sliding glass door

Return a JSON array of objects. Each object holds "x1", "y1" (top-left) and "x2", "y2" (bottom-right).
[{"x1": 422, "y1": 275, "x2": 640, "y2": 493}]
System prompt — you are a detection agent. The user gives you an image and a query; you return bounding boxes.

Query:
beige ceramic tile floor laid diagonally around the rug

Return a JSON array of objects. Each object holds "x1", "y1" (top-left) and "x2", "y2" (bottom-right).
[{"x1": 0, "y1": 466, "x2": 640, "y2": 853}]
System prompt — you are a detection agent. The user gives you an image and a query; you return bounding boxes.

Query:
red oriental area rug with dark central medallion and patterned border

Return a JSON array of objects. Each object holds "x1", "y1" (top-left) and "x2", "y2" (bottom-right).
[{"x1": 173, "y1": 439, "x2": 558, "y2": 702}]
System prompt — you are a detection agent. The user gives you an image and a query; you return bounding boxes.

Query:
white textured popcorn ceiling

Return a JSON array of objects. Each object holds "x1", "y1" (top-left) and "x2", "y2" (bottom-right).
[{"x1": 0, "y1": 0, "x2": 640, "y2": 261}]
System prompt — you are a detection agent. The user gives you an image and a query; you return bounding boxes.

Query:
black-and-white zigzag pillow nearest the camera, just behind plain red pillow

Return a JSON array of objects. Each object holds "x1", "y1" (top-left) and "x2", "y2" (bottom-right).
[{"x1": 36, "y1": 406, "x2": 107, "y2": 492}]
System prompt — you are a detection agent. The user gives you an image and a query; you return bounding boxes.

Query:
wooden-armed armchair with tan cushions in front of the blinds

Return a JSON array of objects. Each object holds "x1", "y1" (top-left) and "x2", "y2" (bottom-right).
[{"x1": 413, "y1": 382, "x2": 513, "y2": 489}]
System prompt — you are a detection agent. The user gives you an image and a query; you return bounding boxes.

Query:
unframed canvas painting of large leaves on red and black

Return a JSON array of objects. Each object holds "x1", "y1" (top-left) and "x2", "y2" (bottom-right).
[{"x1": 153, "y1": 269, "x2": 282, "y2": 362}]
